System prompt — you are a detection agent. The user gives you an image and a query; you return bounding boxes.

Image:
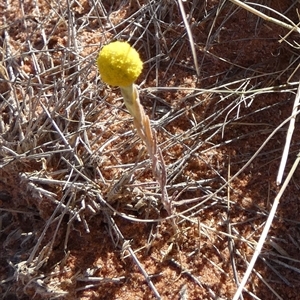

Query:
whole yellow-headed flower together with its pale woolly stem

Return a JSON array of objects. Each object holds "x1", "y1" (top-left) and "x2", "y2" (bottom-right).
[{"x1": 97, "y1": 41, "x2": 173, "y2": 215}]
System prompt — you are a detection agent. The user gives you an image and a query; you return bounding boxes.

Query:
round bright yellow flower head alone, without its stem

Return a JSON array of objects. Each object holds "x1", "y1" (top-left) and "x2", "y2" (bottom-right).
[{"x1": 97, "y1": 41, "x2": 143, "y2": 87}]
